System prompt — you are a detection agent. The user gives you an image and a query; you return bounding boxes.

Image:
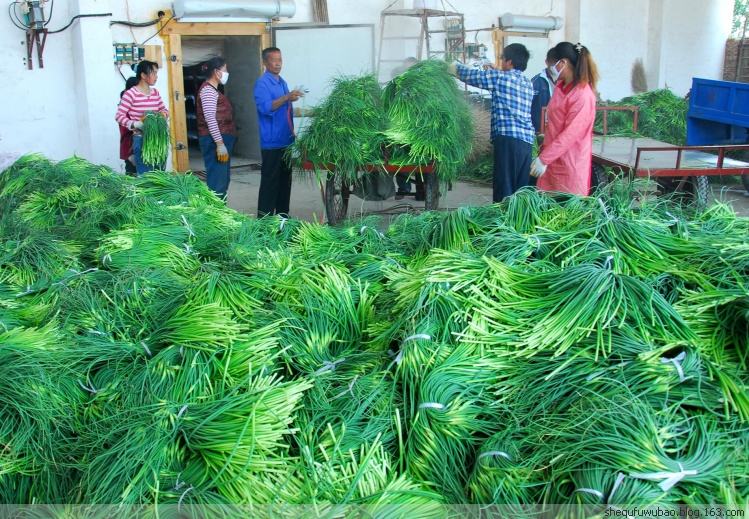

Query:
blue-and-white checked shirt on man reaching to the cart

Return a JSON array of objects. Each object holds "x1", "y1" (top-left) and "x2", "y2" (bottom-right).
[{"x1": 457, "y1": 65, "x2": 536, "y2": 144}]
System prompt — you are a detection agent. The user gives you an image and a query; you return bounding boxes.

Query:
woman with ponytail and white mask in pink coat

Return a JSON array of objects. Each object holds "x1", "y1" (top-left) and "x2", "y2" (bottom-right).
[{"x1": 531, "y1": 41, "x2": 598, "y2": 196}]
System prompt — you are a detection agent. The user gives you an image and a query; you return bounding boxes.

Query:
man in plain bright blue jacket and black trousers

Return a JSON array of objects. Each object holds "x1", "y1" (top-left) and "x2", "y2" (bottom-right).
[{"x1": 254, "y1": 47, "x2": 304, "y2": 217}]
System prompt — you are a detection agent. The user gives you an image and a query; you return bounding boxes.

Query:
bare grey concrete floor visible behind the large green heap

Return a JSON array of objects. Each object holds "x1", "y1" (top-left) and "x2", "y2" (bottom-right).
[{"x1": 205, "y1": 158, "x2": 749, "y2": 224}]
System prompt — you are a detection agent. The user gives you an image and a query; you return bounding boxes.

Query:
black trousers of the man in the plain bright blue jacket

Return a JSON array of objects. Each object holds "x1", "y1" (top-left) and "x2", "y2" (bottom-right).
[{"x1": 257, "y1": 148, "x2": 291, "y2": 217}]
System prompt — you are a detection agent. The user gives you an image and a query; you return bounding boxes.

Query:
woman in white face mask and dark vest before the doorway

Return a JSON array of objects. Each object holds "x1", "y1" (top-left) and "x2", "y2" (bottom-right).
[{"x1": 196, "y1": 57, "x2": 237, "y2": 199}]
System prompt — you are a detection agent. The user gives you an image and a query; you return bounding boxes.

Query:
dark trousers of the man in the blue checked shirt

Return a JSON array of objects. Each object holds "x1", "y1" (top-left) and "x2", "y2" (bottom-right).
[{"x1": 492, "y1": 135, "x2": 533, "y2": 203}]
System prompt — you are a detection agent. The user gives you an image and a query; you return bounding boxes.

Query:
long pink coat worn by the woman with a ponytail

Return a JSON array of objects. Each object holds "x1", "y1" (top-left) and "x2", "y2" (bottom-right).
[{"x1": 537, "y1": 82, "x2": 596, "y2": 196}]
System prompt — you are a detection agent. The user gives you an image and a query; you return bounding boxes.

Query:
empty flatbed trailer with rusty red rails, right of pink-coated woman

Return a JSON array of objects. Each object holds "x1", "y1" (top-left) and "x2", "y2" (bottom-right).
[{"x1": 592, "y1": 106, "x2": 749, "y2": 205}]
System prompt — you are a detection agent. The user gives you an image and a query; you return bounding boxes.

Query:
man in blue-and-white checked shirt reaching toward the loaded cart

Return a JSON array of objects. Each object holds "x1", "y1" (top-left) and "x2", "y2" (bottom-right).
[{"x1": 450, "y1": 43, "x2": 536, "y2": 203}]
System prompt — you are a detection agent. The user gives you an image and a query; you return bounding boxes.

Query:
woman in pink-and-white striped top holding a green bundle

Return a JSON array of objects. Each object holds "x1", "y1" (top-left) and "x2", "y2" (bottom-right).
[{"x1": 114, "y1": 60, "x2": 169, "y2": 176}]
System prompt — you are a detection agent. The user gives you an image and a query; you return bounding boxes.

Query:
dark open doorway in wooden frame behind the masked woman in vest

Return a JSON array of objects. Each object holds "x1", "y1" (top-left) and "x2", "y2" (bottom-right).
[{"x1": 182, "y1": 36, "x2": 262, "y2": 172}]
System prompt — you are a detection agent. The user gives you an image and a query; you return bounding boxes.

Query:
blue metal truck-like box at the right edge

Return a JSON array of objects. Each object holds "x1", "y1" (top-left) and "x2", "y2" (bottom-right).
[{"x1": 687, "y1": 78, "x2": 749, "y2": 146}]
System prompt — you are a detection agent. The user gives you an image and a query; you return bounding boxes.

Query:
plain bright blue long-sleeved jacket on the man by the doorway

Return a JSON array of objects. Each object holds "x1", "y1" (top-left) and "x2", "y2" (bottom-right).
[{"x1": 255, "y1": 70, "x2": 294, "y2": 150}]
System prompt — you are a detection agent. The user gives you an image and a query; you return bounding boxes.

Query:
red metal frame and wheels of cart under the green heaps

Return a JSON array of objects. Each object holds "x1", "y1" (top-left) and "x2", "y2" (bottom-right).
[{"x1": 302, "y1": 160, "x2": 440, "y2": 225}]
